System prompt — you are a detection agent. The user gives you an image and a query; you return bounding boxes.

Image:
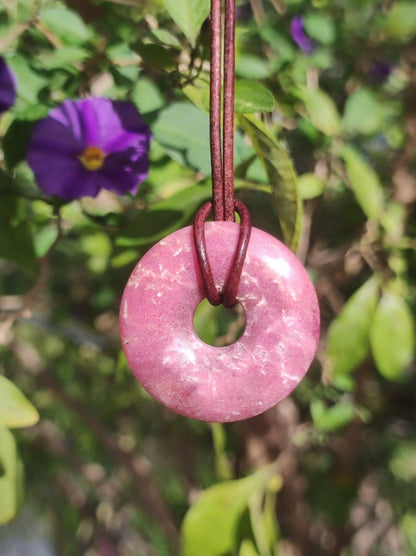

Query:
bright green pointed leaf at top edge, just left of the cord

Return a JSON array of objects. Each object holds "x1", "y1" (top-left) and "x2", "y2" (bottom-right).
[{"x1": 163, "y1": 0, "x2": 210, "y2": 43}]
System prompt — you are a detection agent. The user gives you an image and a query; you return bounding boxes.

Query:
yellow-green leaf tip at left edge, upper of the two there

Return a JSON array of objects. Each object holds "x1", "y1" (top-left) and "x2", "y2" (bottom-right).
[{"x1": 0, "y1": 375, "x2": 39, "y2": 429}]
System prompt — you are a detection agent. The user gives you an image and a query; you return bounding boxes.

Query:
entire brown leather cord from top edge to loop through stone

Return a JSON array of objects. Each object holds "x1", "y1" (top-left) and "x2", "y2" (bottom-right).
[{"x1": 194, "y1": 0, "x2": 251, "y2": 307}]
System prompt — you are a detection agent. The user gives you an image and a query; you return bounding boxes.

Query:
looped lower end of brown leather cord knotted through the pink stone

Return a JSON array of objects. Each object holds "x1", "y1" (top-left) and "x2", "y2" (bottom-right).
[{"x1": 194, "y1": 199, "x2": 251, "y2": 307}]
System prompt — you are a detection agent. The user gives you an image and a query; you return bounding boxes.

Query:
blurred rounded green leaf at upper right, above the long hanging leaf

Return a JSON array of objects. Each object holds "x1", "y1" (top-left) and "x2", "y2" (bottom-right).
[{"x1": 342, "y1": 89, "x2": 383, "y2": 134}]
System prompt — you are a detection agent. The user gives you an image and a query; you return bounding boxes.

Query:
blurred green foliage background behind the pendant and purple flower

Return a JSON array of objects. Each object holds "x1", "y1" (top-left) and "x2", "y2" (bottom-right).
[{"x1": 0, "y1": 0, "x2": 416, "y2": 556}]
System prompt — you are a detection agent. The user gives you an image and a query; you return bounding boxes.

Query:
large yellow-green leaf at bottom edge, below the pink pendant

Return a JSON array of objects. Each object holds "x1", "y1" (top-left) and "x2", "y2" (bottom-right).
[{"x1": 181, "y1": 465, "x2": 275, "y2": 556}]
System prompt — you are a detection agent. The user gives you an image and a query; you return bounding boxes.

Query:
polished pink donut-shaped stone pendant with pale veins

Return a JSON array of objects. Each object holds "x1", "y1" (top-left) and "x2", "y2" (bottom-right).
[{"x1": 120, "y1": 222, "x2": 319, "y2": 422}]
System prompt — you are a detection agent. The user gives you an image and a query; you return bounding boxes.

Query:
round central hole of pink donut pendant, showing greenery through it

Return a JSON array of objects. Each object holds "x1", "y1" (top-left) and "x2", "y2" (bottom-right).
[{"x1": 193, "y1": 299, "x2": 246, "y2": 347}]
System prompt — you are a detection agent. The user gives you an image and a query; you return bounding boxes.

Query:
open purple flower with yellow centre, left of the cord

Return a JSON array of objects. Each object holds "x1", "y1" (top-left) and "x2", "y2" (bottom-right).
[{"x1": 27, "y1": 98, "x2": 151, "y2": 201}]
